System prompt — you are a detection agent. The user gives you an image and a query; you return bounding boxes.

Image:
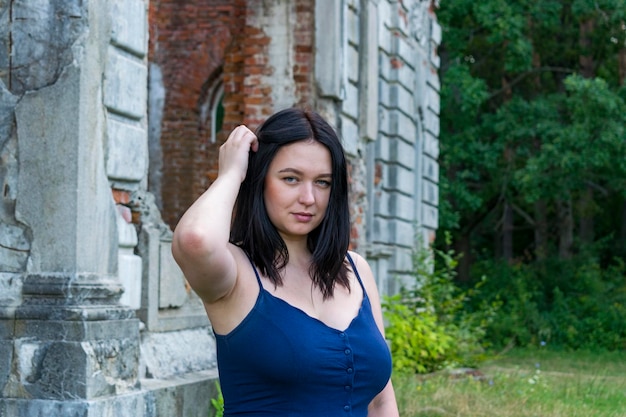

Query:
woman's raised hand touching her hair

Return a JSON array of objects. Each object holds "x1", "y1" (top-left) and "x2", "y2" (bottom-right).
[{"x1": 218, "y1": 125, "x2": 259, "y2": 183}]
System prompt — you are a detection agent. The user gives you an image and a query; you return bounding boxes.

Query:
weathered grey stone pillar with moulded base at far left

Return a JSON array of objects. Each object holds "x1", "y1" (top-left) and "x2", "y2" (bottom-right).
[{"x1": 0, "y1": 0, "x2": 146, "y2": 417}]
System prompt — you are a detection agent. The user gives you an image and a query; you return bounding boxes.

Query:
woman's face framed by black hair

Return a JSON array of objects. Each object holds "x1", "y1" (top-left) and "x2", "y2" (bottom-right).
[{"x1": 264, "y1": 140, "x2": 333, "y2": 241}]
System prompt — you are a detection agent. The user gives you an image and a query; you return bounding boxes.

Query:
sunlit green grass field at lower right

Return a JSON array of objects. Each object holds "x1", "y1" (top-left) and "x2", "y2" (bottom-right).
[{"x1": 393, "y1": 349, "x2": 626, "y2": 417}]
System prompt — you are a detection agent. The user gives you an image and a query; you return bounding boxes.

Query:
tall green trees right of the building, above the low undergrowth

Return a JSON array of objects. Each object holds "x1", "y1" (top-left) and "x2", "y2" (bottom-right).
[{"x1": 438, "y1": 0, "x2": 626, "y2": 272}]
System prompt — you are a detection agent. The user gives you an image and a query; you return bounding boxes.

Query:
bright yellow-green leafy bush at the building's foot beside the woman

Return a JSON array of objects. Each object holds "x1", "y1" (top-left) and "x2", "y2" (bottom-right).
[{"x1": 383, "y1": 237, "x2": 497, "y2": 373}]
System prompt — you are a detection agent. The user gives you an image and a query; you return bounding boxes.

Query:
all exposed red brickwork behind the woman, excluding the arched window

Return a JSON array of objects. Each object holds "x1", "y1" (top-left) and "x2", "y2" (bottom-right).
[{"x1": 149, "y1": 0, "x2": 314, "y2": 228}]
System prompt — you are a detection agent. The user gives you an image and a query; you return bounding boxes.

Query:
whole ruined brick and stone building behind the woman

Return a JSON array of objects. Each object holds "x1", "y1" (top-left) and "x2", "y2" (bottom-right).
[{"x1": 0, "y1": 0, "x2": 441, "y2": 417}]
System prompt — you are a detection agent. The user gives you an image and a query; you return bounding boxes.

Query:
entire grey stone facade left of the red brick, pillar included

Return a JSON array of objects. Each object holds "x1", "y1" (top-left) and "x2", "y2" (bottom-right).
[{"x1": 0, "y1": 0, "x2": 216, "y2": 417}]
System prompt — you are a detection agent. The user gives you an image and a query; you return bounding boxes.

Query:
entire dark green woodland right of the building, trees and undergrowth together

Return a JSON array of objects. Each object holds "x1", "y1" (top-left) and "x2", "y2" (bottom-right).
[{"x1": 437, "y1": 0, "x2": 626, "y2": 349}]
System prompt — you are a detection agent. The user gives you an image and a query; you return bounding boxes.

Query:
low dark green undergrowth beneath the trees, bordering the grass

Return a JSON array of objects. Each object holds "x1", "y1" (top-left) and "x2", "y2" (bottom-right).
[{"x1": 473, "y1": 254, "x2": 626, "y2": 351}]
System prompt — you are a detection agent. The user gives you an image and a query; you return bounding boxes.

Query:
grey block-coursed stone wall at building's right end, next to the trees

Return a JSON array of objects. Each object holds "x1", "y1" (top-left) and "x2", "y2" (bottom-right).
[{"x1": 367, "y1": 0, "x2": 441, "y2": 292}]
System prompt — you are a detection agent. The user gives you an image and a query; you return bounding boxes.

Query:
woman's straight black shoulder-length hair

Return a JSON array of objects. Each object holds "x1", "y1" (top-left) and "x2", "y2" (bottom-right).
[{"x1": 230, "y1": 108, "x2": 350, "y2": 299}]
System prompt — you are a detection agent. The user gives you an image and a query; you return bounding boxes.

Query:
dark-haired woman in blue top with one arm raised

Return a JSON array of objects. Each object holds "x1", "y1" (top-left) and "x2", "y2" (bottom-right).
[{"x1": 172, "y1": 109, "x2": 398, "y2": 417}]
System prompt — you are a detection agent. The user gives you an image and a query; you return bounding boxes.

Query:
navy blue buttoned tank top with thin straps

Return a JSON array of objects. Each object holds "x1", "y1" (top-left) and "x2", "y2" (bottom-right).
[{"x1": 215, "y1": 255, "x2": 391, "y2": 417}]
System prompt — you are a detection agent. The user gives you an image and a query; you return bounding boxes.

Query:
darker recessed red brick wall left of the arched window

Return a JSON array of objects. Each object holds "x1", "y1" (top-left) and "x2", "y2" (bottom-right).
[{"x1": 149, "y1": 0, "x2": 245, "y2": 227}]
